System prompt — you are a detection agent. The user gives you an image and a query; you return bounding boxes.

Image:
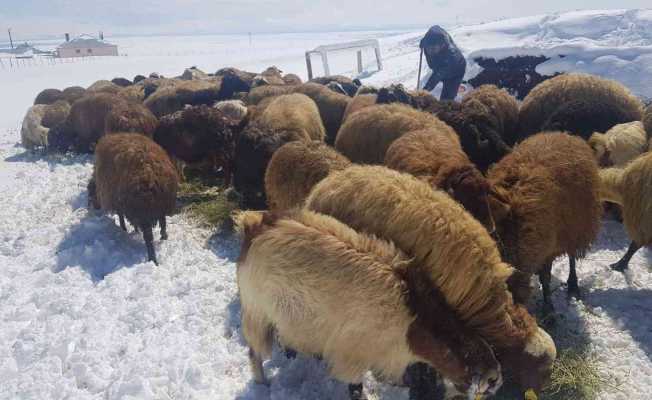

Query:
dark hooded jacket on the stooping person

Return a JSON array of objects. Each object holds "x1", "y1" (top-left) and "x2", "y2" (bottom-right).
[{"x1": 419, "y1": 25, "x2": 466, "y2": 82}]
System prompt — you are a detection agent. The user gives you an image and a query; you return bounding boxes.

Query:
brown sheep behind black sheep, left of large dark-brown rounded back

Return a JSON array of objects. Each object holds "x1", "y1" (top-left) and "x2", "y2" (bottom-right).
[{"x1": 462, "y1": 85, "x2": 518, "y2": 146}]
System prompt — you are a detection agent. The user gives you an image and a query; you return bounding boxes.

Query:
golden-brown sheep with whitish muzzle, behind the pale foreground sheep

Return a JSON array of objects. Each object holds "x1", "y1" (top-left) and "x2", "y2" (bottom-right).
[{"x1": 306, "y1": 166, "x2": 556, "y2": 391}]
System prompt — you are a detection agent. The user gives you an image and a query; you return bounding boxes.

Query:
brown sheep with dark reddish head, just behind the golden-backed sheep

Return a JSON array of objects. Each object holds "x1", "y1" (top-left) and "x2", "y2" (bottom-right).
[{"x1": 385, "y1": 127, "x2": 496, "y2": 233}]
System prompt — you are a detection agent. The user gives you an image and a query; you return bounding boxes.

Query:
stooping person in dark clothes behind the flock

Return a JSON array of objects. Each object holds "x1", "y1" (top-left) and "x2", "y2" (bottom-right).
[{"x1": 419, "y1": 25, "x2": 466, "y2": 100}]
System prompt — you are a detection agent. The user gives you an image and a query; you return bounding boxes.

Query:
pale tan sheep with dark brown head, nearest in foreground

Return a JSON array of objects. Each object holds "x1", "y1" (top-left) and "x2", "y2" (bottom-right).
[{"x1": 237, "y1": 210, "x2": 502, "y2": 400}]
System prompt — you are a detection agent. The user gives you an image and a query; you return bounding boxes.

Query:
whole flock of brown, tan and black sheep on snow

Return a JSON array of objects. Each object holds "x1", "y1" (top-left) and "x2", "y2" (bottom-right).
[{"x1": 17, "y1": 67, "x2": 652, "y2": 400}]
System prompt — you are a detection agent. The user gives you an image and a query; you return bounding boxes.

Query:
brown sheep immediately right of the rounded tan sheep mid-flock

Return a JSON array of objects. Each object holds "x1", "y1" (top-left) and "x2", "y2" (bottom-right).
[{"x1": 294, "y1": 83, "x2": 351, "y2": 145}]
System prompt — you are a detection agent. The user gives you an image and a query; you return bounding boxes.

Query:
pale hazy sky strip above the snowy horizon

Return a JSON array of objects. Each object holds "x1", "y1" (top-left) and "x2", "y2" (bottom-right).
[{"x1": 0, "y1": 0, "x2": 651, "y2": 41}]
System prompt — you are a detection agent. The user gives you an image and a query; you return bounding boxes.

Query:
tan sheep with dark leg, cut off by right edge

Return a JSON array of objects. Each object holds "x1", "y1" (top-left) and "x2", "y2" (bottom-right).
[{"x1": 600, "y1": 153, "x2": 652, "y2": 271}]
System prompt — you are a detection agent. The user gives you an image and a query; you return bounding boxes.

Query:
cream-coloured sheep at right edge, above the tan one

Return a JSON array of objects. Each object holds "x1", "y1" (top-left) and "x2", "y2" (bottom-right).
[{"x1": 589, "y1": 121, "x2": 648, "y2": 167}]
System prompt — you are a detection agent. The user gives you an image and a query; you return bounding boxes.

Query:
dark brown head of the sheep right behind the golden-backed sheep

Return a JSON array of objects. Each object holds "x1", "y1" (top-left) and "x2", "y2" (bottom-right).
[{"x1": 444, "y1": 165, "x2": 496, "y2": 233}]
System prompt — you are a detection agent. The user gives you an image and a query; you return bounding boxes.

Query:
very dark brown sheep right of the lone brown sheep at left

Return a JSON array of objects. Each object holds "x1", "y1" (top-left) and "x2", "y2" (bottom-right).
[{"x1": 154, "y1": 105, "x2": 235, "y2": 186}]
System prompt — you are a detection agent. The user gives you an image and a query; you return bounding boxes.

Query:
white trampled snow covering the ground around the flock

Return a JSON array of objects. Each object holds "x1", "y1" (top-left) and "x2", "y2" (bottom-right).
[{"x1": 0, "y1": 11, "x2": 652, "y2": 400}]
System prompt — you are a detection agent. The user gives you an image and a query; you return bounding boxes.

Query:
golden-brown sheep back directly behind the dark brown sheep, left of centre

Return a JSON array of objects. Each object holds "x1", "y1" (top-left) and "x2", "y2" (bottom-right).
[{"x1": 145, "y1": 80, "x2": 221, "y2": 118}]
